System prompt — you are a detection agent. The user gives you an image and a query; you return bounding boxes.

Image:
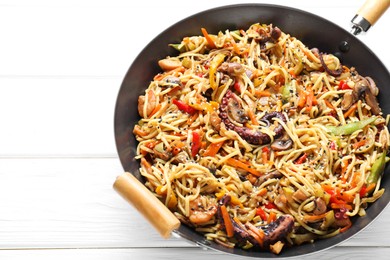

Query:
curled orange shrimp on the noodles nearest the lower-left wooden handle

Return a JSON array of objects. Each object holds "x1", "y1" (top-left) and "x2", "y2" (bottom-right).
[{"x1": 189, "y1": 197, "x2": 218, "y2": 225}]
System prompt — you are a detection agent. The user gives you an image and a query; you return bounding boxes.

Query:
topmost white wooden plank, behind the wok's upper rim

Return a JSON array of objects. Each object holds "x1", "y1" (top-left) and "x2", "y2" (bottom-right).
[{"x1": 0, "y1": 0, "x2": 390, "y2": 76}]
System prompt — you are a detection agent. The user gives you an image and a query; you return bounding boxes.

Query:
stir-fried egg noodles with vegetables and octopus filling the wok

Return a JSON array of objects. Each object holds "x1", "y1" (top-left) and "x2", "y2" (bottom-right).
[{"x1": 133, "y1": 24, "x2": 390, "y2": 253}]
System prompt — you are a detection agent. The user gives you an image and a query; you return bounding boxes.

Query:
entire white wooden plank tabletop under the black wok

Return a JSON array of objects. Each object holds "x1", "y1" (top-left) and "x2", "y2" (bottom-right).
[{"x1": 0, "y1": 0, "x2": 390, "y2": 260}]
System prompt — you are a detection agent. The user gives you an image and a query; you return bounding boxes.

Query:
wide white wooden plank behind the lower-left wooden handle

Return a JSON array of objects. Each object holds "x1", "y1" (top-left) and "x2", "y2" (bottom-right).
[{"x1": 0, "y1": 158, "x2": 390, "y2": 249}]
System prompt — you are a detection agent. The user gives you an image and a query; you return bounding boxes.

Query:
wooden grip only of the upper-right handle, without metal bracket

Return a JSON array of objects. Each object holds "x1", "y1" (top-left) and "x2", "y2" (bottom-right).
[{"x1": 357, "y1": 0, "x2": 390, "y2": 26}]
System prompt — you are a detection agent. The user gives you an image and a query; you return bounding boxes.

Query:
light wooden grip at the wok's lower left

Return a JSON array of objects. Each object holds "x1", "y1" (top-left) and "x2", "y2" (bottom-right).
[{"x1": 114, "y1": 172, "x2": 180, "y2": 238}]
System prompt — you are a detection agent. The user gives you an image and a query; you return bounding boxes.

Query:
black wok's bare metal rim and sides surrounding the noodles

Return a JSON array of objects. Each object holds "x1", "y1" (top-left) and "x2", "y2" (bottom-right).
[{"x1": 114, "y1": 4, "x2": 390, "y2": 258}]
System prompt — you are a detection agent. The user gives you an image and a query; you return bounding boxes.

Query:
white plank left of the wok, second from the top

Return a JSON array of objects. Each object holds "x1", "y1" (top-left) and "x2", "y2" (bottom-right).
[{"x1": 0, "y1": 77, "x2": 122, "y2": 157}]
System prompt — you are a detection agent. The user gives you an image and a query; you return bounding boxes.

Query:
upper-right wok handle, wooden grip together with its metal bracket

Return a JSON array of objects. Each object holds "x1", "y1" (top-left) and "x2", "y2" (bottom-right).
[{"x1": 351, "y1": 0, "x2": 390, "y2": 35}]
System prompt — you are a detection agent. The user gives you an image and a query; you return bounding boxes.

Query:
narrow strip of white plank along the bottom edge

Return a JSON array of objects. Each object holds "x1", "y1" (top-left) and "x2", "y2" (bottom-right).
[{"x1": 0, "y1": 247, "x2": 390, "y2": 260}]
